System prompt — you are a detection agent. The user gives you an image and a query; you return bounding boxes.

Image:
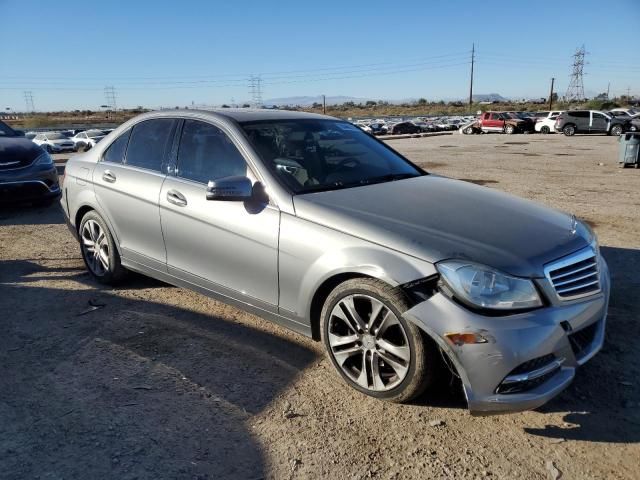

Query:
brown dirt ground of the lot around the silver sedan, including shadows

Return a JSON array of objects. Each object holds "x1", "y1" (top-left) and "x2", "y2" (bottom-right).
[{"x1": 0, "y1": 134, "x2": 640, "y2": 480}]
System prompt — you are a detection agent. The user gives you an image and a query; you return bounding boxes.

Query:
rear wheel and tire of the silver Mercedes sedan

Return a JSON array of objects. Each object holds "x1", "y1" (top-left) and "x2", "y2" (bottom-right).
[{"x1": 78, "y1": 210, "x2": 127, "y2": 285}]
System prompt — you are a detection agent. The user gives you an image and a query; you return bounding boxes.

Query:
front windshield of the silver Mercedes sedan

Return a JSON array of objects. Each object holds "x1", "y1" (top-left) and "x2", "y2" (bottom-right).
[{"x1": 241, "y1": 120, "x2": 424, "y2": 194}]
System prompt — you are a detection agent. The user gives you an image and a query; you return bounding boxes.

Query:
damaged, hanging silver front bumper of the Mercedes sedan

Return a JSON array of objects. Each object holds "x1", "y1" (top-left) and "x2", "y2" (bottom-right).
[{"x1": 404, "y1": 258, "x2": 610, "y2": 415}]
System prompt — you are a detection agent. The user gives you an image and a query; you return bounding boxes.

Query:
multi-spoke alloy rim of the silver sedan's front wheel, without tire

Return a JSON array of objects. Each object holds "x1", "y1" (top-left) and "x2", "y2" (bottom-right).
[{"x1": 327, "y1": 294, "x2": 411, "y2": 392}]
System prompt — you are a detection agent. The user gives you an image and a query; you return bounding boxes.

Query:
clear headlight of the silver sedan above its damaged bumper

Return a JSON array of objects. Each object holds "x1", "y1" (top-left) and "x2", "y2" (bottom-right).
[{"x1": 436, "y1": 260, "x2": 542, "y2": 310}]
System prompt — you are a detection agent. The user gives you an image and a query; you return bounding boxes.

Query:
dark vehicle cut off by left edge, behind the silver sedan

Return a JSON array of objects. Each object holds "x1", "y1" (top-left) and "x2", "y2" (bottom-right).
[{"x1": 0, "y1": 122, "x2": 60, "y2": 205}]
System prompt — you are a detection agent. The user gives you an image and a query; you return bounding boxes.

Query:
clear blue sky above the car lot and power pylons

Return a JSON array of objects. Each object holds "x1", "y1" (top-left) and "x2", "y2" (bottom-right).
[{"x1": 0, "y1": 0, "x2": 640, "y2": 110}]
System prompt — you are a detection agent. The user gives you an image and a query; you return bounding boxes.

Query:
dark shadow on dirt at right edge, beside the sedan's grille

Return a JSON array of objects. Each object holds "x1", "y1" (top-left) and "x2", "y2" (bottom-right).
[{"x1": 525, "y1": 247, "x2": 640, "y2": 443}]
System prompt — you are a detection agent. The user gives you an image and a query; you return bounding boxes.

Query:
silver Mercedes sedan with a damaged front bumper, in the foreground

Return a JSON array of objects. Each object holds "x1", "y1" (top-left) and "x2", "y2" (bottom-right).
[{"x1": 61, "y1": 109, "x2": 610, "y2": 414}]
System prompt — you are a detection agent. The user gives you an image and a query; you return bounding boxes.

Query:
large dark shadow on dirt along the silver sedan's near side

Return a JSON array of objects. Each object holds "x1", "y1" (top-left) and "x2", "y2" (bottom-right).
[{"x1": 0, "y1": 259, "x2": 317, "y2": 478}]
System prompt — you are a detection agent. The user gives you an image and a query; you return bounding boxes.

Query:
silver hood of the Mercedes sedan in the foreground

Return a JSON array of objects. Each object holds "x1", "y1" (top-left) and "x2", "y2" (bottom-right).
[{"x1": 294, "y1": 175, "x2": 593, "y2": 277}]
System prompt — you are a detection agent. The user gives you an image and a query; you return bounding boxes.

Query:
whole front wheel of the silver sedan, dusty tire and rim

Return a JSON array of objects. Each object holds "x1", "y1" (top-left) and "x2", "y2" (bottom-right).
[{"x1": 321, "y1": 278, "x2": 437, "y2": 403}]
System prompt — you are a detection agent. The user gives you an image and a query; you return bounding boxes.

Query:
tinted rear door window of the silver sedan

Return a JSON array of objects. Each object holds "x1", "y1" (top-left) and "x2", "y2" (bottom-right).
[{"x1": 125, "y1": 118, "x2": 177, "y2": 172}]
